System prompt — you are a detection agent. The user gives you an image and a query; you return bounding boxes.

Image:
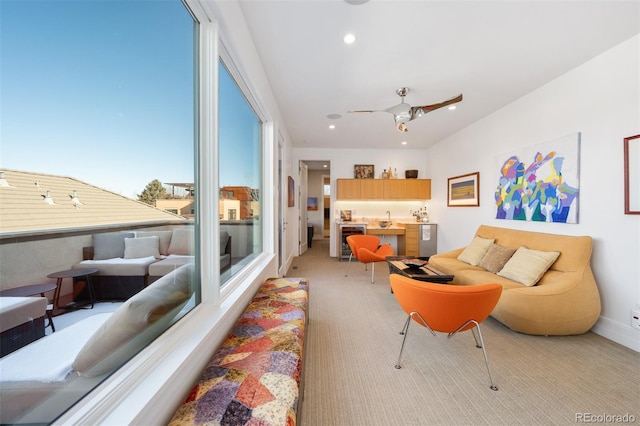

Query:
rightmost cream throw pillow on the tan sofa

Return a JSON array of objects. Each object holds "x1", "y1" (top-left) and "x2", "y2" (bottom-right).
[{"x1": 498, "y1": 247, "x2": 560, "y2": 287}]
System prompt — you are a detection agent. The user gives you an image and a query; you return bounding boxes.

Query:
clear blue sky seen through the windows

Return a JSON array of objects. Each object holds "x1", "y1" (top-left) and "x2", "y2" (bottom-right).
[{"x1": 0, "y1": 0, "x2": 255, "y2": 198}]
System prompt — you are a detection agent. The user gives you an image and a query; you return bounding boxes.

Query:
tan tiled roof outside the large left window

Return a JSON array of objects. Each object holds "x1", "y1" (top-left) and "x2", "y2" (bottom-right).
[{"x1": 0, "y1": 169, "x2": 184, "y2": 234}]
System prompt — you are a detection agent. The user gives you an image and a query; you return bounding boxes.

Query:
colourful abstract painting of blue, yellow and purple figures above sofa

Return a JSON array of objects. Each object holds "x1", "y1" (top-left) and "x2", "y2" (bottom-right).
[{"x1": 495, "y1": 133, "x2": 580, "y2": 223}]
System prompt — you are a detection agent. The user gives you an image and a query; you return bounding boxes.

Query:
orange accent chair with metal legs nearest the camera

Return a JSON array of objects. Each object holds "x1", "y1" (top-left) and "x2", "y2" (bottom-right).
[{"x1": 389, "y1": 274, "x2": 502, "y2": 391}]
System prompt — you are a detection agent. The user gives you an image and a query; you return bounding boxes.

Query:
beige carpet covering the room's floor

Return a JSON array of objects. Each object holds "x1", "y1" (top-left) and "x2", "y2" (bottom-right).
[{"x1": 287, "y1": 240, "x2": 640, "y2": 426}]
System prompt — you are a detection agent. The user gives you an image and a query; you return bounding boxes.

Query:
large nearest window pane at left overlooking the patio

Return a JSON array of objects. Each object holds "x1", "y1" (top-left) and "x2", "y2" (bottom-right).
[{"x1": 0, "y1": 0, "x2": 199, "y2": 424}]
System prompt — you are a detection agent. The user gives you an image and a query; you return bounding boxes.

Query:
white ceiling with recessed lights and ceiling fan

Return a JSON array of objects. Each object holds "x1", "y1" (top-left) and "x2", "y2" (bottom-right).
[{"x1": 240, "y1": 0, "x2": 640, "y2": 153}]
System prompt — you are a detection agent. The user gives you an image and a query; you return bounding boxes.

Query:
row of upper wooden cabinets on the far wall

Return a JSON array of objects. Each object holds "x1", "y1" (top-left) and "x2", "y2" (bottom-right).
[{"x1": 336, "y1": 179, "x2": 431, "y2": 200}]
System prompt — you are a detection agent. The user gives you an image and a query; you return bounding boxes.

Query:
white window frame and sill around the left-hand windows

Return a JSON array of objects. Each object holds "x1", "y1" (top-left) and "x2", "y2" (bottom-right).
[{"x1": 53, "y1": 0, "x2": 277, "y2": 424}]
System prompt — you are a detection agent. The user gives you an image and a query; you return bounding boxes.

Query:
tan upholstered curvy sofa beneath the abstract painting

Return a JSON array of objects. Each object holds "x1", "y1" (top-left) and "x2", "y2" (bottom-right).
[{"x1": 429, "y1": 225, "x2": 600, "y2": 335}]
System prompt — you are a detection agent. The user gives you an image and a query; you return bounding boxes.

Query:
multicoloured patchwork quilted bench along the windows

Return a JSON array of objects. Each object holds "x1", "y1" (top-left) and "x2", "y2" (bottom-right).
[{"x1": 169, "y1": 278, "x2": 309, "y2": 426}]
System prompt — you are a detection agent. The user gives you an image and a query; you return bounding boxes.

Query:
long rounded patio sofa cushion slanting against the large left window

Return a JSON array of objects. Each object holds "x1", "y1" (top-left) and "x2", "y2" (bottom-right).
[{"x1": 72, "y1": 264, "x2": 193, "y2": 377}]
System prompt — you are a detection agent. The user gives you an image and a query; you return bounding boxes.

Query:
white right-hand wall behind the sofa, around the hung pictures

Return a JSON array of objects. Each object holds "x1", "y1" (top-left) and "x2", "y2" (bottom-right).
[{"x1": 427, "y1": 36, "x2": 640, "y2": 351}]
